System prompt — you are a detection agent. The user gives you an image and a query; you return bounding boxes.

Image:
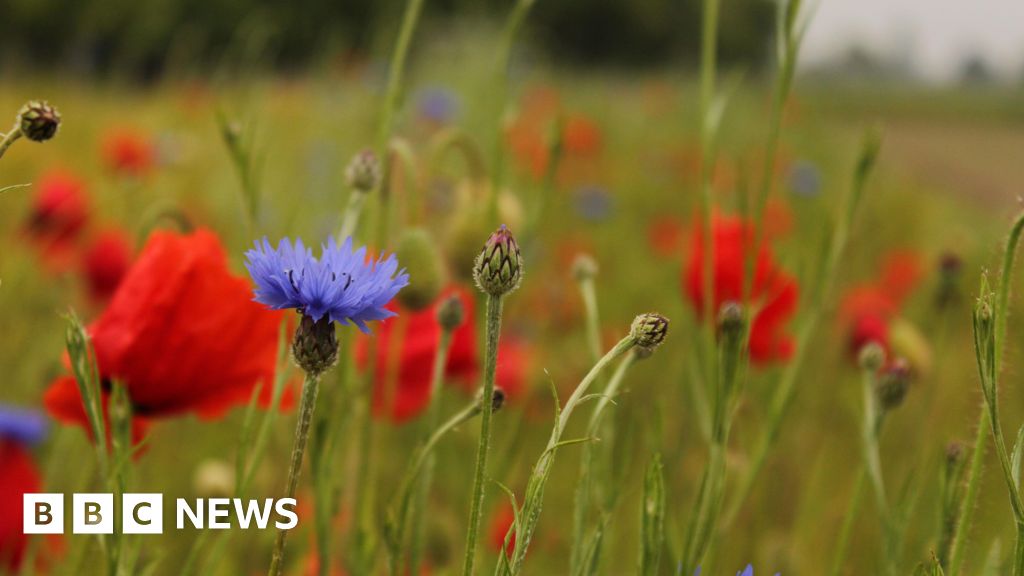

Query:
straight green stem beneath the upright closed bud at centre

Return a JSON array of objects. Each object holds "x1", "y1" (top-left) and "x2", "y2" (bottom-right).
[{"x1": 462, "y1": 294, "x2": 503, "y2": 576}]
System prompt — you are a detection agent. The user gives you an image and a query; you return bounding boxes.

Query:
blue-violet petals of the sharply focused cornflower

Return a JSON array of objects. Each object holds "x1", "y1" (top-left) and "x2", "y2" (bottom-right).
[{"x1": 246, "y1": 233, "x2": 409, "y2": 333}]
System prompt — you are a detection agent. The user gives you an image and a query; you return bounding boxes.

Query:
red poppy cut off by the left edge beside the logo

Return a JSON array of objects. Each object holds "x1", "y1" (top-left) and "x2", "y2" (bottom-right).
[{"x1": 0, "y1": 440, "x2": 42, "y2": 572}]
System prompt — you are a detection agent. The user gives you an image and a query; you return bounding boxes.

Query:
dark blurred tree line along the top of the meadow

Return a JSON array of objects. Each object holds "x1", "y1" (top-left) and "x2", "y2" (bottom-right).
[{"x1": 0, "y1": 0, "x2": 774, "y2": 78}]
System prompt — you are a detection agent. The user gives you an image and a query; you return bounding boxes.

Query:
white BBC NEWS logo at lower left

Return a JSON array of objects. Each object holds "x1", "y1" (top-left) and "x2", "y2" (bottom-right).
[{"x1": 22, "y1": 493, "x2": 299, "y2": 534}]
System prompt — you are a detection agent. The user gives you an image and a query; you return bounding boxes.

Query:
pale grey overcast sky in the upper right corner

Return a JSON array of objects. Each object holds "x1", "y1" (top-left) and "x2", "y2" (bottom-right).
[{"x1": 802, "y1": 0, "x2": 1024, "y2": 81}]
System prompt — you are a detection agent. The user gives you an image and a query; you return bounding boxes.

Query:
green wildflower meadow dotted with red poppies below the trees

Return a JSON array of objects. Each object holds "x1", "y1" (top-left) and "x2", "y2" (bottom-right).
[{"x1": 0, "y1": 5, "x2": 1024, "y2": 576}]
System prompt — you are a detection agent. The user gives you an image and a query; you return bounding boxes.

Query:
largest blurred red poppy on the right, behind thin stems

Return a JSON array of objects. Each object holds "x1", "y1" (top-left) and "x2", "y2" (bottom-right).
[{"x1": 683, "y1": 216, "x2": 799, "y2": 364}]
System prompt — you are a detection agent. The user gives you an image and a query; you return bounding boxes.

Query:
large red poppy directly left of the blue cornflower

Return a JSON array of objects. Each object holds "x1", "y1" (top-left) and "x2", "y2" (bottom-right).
[{"x1": 45, "y1": 231, "x2": 282, "y2": 438}]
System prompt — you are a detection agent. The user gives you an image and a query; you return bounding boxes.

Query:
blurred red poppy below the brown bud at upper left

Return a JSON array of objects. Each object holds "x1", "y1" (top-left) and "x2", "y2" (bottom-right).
[{"x1": 25, "y1": 170, "x2": 89, "y2": 270}]
